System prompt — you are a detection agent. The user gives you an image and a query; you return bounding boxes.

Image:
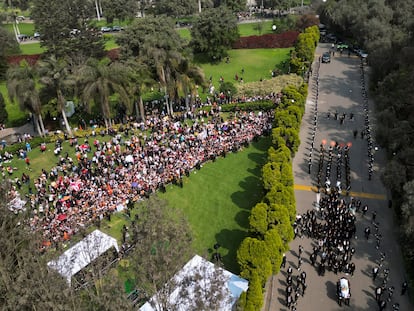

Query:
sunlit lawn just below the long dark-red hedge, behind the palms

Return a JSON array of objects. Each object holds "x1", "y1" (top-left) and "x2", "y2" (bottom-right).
[{"x1": 198, "y1": 48, "x2": 290, "y2": 89}]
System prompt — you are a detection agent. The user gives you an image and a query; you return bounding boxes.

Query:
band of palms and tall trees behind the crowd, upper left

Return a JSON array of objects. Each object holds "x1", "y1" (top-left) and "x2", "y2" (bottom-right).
[{"x1": 0, "y1": 0, "x2": 246, "y2": 129}]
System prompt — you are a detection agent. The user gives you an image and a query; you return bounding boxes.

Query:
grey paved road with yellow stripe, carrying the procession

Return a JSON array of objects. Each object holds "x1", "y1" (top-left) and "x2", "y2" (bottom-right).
[{"x1": 263, "y1": 44, "x2": 414, "y2": 311}]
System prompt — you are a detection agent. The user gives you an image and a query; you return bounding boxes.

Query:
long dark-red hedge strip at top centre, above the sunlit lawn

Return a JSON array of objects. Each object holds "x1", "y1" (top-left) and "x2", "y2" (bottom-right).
[{"x1": 233, "y1": 31, "x2": 299, "y2": 49}]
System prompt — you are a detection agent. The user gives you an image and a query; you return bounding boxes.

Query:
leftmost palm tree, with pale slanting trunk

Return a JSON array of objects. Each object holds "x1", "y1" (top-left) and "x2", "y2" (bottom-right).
[{"x1": 7, "y1": 61, "x2": 45, "y2": 136}]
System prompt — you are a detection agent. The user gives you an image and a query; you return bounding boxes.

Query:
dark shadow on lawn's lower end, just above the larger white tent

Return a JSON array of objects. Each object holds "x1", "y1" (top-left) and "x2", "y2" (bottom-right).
[{"x1": 216, "y1": 229, "x2": 247, "y2": 275}]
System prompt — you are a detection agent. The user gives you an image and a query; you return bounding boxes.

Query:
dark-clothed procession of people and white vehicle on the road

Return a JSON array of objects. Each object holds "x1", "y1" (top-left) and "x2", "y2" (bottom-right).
[{"x1": 281, "y1": 50, "x2": 408, "y2": 311}]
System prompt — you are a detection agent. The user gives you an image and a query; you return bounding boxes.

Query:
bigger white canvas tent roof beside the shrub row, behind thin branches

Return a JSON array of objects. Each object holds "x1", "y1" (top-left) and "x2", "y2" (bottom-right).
[{"x1": 140, "y1": 255, "x2": 248, "y2": 311}]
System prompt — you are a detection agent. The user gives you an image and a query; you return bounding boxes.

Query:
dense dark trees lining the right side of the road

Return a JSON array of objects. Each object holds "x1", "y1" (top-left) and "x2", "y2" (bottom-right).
[{"x1": 320, "y1": 0, "x2": 414, "y2": 288}]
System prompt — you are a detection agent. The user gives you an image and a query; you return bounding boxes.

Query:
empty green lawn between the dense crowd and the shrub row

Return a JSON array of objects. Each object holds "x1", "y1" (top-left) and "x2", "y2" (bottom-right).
[{"x1": 159, "y1": 138, "x2": 271, "y2": 273}]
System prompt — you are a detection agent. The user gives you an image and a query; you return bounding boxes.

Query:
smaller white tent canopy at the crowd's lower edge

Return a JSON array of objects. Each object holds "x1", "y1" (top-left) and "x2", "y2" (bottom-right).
[{"x1": 47, "y1": 230, "x2": 119, "y2": 284}]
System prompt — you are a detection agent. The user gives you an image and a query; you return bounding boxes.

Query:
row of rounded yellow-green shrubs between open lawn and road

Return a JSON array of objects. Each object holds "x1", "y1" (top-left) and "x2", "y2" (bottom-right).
[{"x1": 237, "y1": 85, "x2": 307, "y2": 311}]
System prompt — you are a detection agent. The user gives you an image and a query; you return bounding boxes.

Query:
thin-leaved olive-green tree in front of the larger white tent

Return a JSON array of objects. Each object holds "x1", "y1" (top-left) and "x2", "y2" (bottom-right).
[{"x1": 130, "y1": 196, "x2": 192, "y2": 310}]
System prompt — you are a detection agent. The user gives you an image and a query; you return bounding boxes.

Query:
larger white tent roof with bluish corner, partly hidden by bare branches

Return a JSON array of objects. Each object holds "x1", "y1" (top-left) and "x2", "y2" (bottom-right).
[{"x1": 140, "y1": 255, "x2": 248, "y2": 311}]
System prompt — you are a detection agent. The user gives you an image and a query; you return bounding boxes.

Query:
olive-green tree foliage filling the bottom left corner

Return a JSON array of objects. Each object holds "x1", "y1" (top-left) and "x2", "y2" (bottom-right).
[{"x1": 0, "y1": 182, "x2": 80, "y2": 311}]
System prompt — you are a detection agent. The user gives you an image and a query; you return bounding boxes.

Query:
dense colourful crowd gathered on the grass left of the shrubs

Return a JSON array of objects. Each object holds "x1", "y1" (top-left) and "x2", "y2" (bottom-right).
[{"x1": 5, "y1": 111, "x2": 273, "y2": 246}]
